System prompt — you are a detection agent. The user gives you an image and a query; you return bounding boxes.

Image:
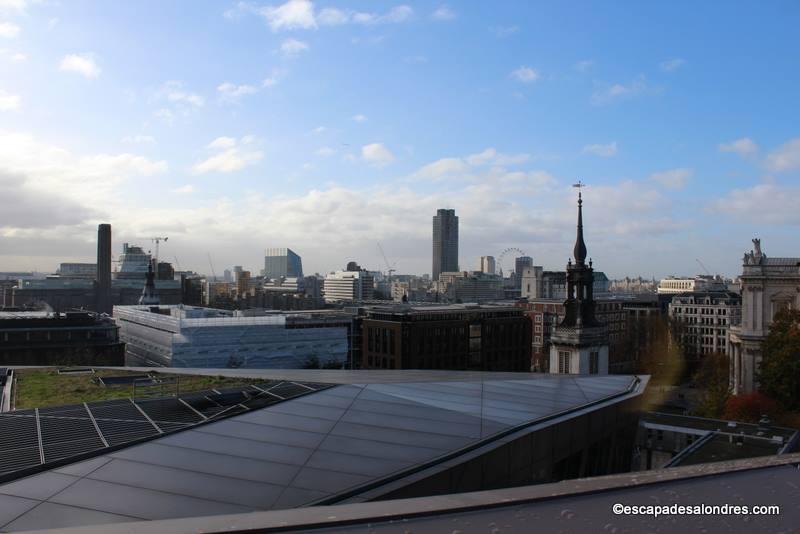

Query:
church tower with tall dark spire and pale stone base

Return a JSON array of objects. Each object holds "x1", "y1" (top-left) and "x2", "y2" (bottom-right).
[{"x1": 550, "y1": 182, "x2": 608, "y2": 374}]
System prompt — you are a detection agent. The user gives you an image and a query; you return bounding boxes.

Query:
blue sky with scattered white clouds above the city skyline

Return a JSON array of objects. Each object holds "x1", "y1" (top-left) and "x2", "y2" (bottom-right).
[{"x1": 0, "y1": 0, "x2": 800, "y2": 278}]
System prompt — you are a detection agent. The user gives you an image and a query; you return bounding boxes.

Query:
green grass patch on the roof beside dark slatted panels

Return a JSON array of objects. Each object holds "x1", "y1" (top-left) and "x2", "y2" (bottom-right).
[{"x1": 14, "y1": 367, "x2": 264, "y2": 410}]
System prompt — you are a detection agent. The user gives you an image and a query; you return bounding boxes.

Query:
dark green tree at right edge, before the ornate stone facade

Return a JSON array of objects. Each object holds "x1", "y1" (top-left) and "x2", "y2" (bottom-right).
[{"x1": 758, "y1": 310, "x2": 800, "y2": 411}]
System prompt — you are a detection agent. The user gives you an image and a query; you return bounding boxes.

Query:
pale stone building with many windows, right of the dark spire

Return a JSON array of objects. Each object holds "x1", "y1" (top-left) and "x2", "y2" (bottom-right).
[{"x1": 668, "y1": 291, "x2": 742, "y2": 361}]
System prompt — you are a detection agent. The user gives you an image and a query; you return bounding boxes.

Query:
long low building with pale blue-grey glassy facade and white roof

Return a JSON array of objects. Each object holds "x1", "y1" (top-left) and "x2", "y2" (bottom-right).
[{"x1": 114, "y1": 305, "x2": 352, "y2": 369}]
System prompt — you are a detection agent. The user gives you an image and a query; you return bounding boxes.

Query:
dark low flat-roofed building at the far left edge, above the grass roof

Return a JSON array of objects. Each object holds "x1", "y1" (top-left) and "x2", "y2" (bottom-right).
[{"x1": 0, "y1": 312, "x2": 125, "y2": 365}]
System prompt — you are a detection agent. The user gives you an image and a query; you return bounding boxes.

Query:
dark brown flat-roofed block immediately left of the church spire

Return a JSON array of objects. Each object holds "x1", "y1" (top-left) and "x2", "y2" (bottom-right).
[{"x1": 361, "y1": 305, "x2": 531, "y2": 371}]
